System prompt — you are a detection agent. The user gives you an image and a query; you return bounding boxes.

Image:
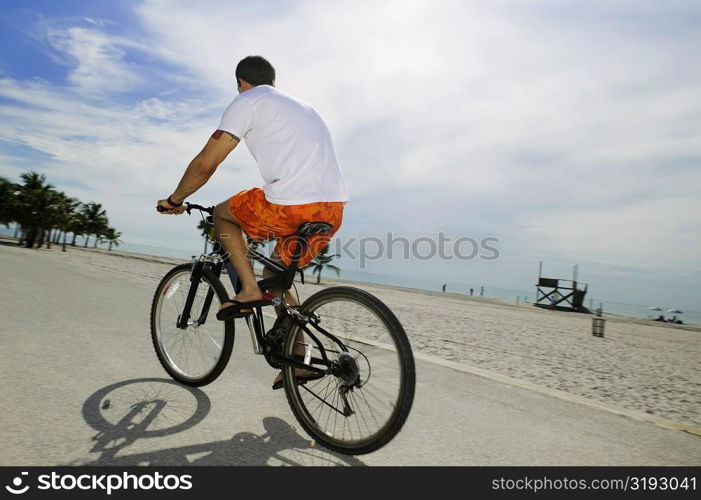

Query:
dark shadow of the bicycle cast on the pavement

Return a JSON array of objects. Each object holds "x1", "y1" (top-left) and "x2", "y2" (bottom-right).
[{"x1": 80, "y1": 378, "x2": 365, "y2": 466}]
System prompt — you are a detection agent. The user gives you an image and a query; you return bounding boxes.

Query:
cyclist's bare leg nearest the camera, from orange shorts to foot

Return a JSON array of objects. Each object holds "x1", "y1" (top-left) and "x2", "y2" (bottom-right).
[{"x1": 214, "y1": 200, "x2": 263, "y2": 309}]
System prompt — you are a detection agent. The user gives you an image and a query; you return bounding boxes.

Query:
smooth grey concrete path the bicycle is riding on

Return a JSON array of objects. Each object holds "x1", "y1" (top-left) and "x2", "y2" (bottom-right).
[{"x1": 0, "y1": 245, "x2": 701, "y2": 466}]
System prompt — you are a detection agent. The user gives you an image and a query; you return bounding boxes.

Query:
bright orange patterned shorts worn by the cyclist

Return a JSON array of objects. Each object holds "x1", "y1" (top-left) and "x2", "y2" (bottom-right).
[{"x1": 229, "y1": 188, "x2": 345, "y2": 267}]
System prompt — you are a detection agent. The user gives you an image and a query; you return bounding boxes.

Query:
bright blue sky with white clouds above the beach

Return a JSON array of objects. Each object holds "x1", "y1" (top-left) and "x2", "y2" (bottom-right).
[{"x1": 0, "y1": 0, "x2": 701, "y2": 310}]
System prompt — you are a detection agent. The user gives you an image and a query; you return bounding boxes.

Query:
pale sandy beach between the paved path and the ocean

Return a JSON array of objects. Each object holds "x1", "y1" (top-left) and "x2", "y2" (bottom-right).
[{"x1": 5, "y1": 239, "x2": 701, "y2": 425}]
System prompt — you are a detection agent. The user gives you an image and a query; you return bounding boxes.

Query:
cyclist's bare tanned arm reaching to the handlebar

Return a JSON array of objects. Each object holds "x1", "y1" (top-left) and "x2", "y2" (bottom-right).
[{"x1": 158, "y1": 130, "x2": 239, "y2": 214}]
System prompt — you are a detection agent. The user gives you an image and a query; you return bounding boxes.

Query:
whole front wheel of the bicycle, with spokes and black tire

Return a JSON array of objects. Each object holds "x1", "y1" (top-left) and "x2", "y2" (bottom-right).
[{"x1": 151, "y1": 264, "x2": 234, "y2": 386}]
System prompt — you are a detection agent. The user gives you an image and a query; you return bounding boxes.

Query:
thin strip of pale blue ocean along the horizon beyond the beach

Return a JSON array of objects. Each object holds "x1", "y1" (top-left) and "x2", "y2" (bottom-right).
[{"x1": 0, "y1": 226, "x2": 701, "y2": 325}]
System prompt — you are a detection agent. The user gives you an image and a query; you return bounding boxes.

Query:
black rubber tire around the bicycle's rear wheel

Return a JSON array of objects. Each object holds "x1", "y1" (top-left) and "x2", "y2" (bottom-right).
[{"x1": 283, "y1": 286, "x2": 416, "y2": 455}]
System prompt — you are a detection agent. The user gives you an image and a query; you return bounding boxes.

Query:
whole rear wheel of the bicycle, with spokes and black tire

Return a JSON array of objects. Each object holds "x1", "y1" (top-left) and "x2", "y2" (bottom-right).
[{"x1": 283, "y1": 287, "x2": 416, "y2": 455}]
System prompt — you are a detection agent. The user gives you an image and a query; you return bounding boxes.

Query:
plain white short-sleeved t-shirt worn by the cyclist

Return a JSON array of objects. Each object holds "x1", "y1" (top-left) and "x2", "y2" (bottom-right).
[{"x1": 219, "y1": 85, "x2": 348, "y2": 205}]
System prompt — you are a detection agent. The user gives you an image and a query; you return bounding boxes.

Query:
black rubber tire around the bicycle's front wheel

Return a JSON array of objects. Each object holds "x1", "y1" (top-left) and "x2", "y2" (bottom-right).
[{"x1": 151, "y1": 264, "x2": 234, "y2": 387}]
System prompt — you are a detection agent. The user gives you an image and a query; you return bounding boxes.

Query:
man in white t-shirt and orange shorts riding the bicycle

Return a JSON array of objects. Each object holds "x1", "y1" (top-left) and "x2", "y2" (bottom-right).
[{"x1": 158, "y1": 56, "x2": 348, "y2": 385}]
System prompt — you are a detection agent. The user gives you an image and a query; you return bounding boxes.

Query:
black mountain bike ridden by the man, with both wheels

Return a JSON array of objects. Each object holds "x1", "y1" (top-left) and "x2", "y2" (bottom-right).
[{"x1": 151, "y1": 203, "x2": 416, "y2": 455}]
